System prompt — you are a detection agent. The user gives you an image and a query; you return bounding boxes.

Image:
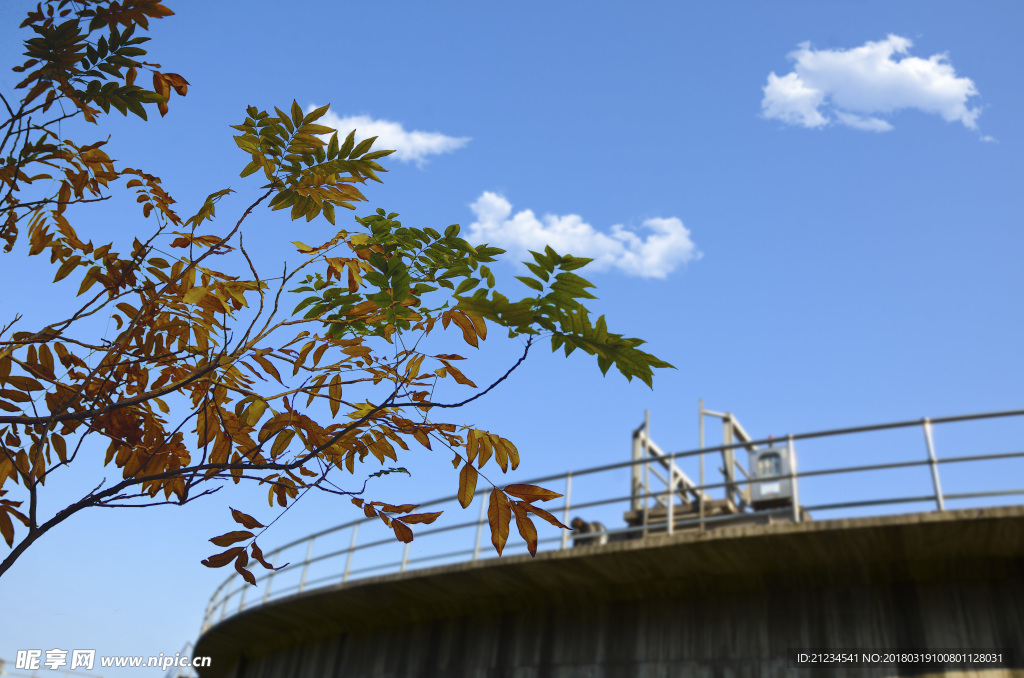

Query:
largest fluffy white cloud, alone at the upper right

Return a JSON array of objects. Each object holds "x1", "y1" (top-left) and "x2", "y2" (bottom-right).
[{"x1": 761, "y1": 35, "x2": 981, "y2": 132}]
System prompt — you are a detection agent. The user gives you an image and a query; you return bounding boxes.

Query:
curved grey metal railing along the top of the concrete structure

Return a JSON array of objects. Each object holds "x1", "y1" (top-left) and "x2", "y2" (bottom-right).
[{"x1": 197, "y1": 410, "x2": 1024, "y2": 631}]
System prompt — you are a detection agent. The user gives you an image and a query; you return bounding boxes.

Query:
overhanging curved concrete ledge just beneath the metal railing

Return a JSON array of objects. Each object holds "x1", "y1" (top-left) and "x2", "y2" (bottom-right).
[{"x1": 195, "y1": 506, "x2": 1024, "y2": 678}]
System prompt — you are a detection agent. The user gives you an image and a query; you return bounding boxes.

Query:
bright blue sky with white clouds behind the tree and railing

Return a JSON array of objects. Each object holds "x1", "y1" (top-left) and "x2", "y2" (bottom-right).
[{"x1": 0, "y1": 0, "x2": 1024, "y2": 675}]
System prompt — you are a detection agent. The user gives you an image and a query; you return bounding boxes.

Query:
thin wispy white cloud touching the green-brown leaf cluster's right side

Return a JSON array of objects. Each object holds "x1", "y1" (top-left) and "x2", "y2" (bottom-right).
[{"x1": 306, "y1": 104, "x2": 470, "y2": 167}]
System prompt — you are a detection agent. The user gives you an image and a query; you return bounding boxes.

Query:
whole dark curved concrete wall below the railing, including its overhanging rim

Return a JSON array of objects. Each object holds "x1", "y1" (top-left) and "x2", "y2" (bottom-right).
[{"x1": 196, "y1": 507, "x2": 1024, "y2": 678}]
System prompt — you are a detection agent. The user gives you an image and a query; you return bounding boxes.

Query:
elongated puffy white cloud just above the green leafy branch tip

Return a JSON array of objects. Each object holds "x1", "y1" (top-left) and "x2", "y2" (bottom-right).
[{"x1": 469, "y1": 190, "x2": 700, "y2": 279}]
